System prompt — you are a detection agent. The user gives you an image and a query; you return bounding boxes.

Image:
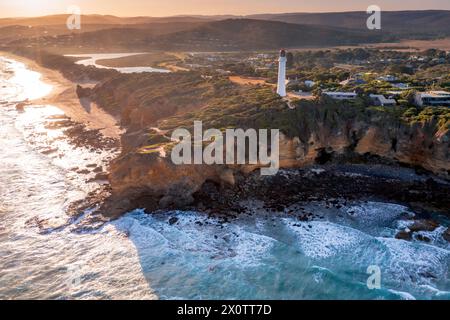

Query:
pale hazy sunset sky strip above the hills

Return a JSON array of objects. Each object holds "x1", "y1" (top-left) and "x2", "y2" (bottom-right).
[{"x1": 0, "y1": 0, "x2": 450, "y2": 17}]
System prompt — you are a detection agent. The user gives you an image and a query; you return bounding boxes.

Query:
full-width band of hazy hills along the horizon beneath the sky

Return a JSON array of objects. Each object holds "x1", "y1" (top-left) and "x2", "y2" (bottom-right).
[{"x1": 0, "y1": 10, "x2": 450, "y2": 51}]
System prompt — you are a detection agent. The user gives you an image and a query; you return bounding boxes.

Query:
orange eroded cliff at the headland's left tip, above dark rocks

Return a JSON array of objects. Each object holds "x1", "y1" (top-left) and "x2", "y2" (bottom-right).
[{"x1": 110, "y1": 153, "x2": 234, "y2": 208}]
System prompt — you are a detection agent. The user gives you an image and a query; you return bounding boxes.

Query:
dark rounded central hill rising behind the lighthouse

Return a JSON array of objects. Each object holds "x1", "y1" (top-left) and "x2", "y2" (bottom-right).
[{"x1": 149, "y1": 19, "x2": 386, "y2": 50}]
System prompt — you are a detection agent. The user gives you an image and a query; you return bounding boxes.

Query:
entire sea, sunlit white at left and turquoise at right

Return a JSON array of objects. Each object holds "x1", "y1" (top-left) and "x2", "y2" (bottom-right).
[{"x1": 0, "y1": 55, "x2": 450, "y2": 299}]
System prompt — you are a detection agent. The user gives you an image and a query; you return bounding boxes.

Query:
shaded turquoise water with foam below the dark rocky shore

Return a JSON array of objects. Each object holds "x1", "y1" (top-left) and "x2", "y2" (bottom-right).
[{"x1": 114, "y1": 203, "x2": 450, "y2": 299}]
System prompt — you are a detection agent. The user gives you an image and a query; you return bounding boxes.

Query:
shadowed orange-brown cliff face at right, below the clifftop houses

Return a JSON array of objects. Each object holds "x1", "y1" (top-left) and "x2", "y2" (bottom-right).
[{"x1": 280, "y1": 115, "x2": 450, "y2": 178}]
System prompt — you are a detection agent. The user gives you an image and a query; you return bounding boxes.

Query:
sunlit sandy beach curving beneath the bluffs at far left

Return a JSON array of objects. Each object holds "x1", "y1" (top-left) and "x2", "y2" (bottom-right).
[{"x1": 0, "y1": 51, "x2": 122, "y2": 138}]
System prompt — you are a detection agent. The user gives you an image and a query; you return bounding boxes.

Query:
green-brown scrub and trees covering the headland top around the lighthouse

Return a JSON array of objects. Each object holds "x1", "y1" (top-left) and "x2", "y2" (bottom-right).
[{"x1": 5, "y1": 48, "x2": 450, "y2": 143}]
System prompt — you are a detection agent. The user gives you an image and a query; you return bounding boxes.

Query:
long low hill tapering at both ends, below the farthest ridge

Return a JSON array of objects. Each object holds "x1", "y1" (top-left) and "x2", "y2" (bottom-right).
[{"x1": 7, "y1": 19, "x2": 382, "y2": 51}]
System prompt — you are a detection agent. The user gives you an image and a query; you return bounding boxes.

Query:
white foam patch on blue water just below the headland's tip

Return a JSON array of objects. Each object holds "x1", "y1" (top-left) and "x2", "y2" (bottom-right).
[{"x1": 114, "y1": 211, "x2": 276, "y2": 267}]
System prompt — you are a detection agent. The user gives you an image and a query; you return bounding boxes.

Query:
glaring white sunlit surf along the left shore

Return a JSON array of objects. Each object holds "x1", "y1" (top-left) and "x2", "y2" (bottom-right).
[{"x1": 0, "y1": 59, "x2": 156, "y2": 299}]
